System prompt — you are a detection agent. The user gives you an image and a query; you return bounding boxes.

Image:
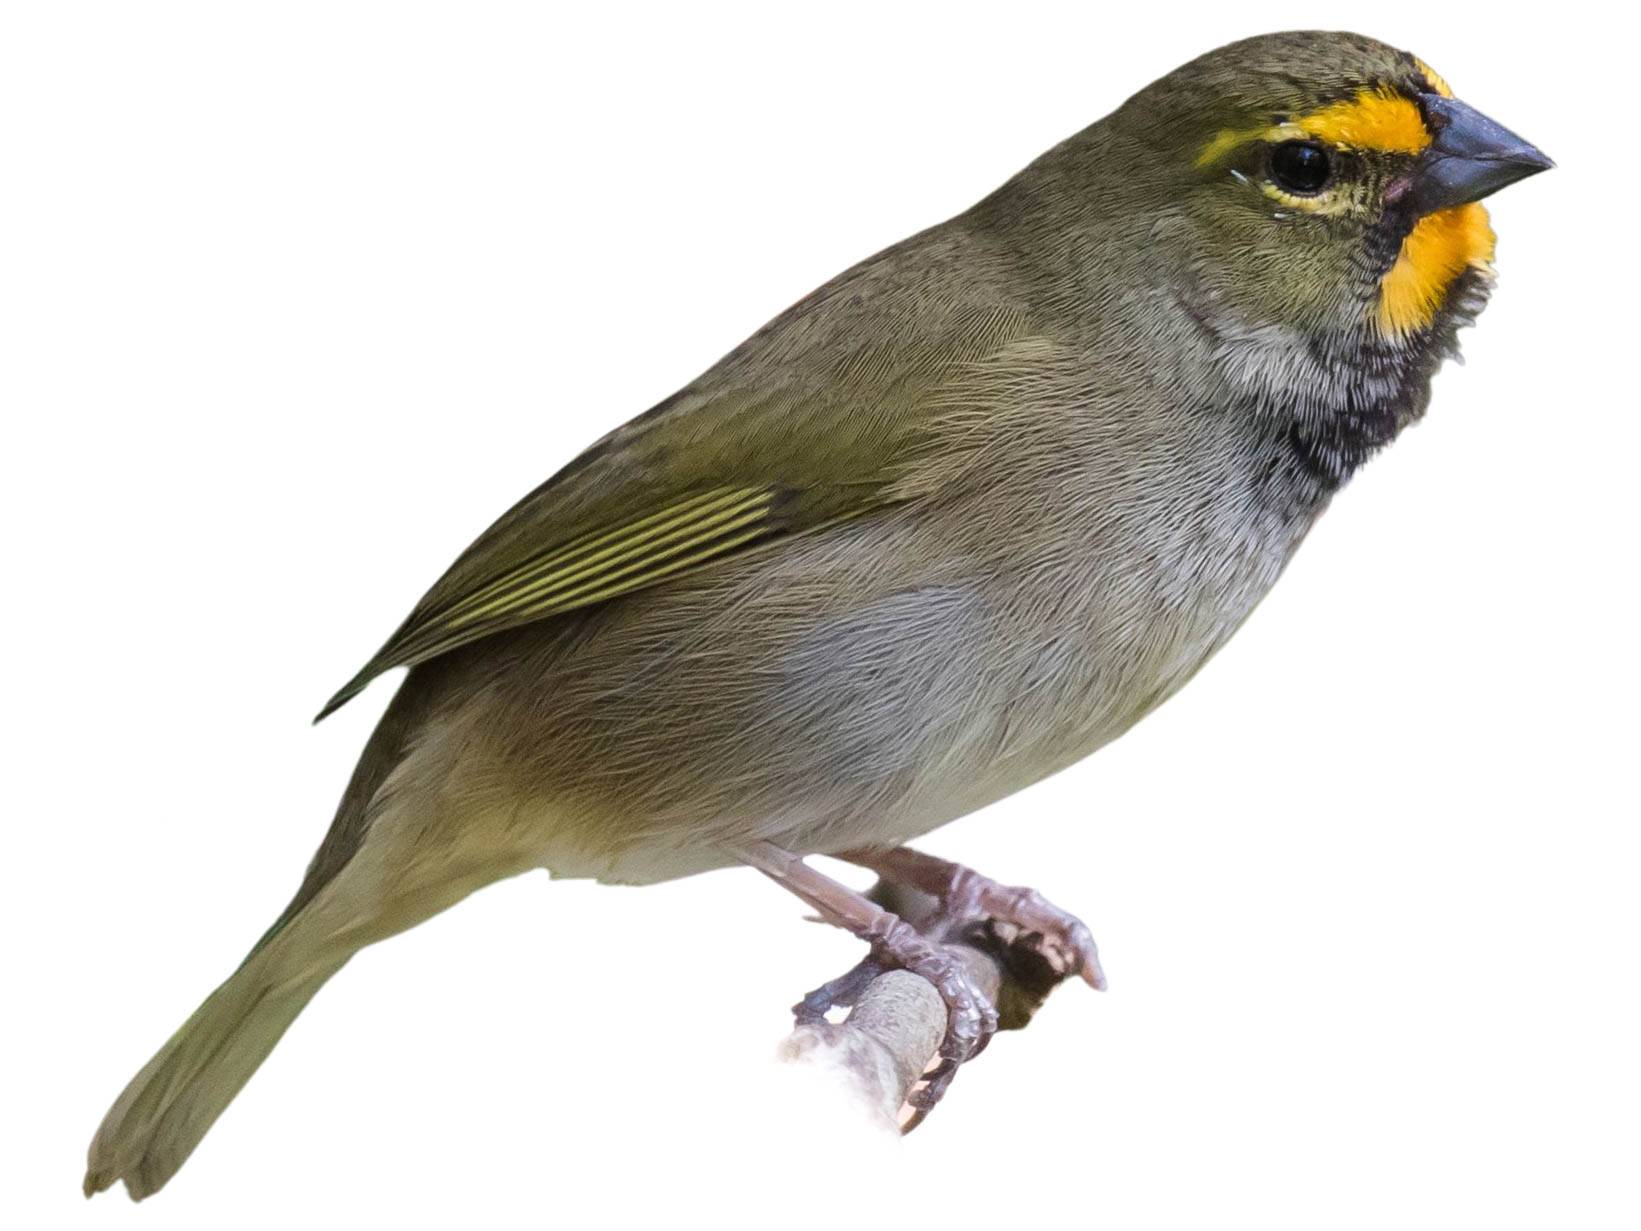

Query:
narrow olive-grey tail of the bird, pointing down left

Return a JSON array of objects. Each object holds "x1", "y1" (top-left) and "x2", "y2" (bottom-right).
[{"x1": 85, "y1": 950, "x2": 346, "y2": 1201}]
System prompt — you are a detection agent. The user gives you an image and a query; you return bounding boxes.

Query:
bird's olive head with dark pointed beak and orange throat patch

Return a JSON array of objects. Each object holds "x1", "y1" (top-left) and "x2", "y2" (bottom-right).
[{"x1": 1114, "y1": 33, "x2": 1551, "y2": 349}]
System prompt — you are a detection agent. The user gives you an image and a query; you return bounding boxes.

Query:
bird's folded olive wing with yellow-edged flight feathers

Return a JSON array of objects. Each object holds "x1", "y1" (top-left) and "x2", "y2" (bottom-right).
[{"x1": 315, "y1": 284, "x2": 1024, "y2": 722}]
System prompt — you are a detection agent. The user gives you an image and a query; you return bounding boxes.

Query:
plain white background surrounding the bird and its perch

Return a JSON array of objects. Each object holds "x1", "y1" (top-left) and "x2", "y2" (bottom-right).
[{"x1": 0, "y1": 0, "x2": 1641, "y2": 1228}]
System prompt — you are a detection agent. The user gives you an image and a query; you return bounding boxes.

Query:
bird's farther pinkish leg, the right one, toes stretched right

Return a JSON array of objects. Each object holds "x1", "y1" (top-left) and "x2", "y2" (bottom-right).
[{"x1": 837, "y1": 847, "x2": 1106, "y2": 991}]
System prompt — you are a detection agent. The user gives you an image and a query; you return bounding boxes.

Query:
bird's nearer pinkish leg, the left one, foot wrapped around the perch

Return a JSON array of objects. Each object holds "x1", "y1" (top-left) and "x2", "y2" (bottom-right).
[{"x1": 735, "y1": 842, "x2": 998, "y2": 1110}]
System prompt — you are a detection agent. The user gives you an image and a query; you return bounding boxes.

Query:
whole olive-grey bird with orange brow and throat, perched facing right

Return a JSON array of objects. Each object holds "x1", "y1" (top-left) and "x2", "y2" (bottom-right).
[{"x1": 84, "y1": 31, "x2": 1552, "y2": 1200}]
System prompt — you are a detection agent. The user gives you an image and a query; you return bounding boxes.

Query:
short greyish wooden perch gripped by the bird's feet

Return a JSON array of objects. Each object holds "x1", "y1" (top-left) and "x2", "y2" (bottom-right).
[{"x1": 779, "y1": 881, "x2": 1068, "y2": 1131}]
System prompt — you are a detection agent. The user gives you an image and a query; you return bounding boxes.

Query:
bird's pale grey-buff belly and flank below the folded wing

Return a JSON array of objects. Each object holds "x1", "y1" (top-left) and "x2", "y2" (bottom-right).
[{"x1": 400, "y1": 443, "x2": 1319, "y2": 883}]
